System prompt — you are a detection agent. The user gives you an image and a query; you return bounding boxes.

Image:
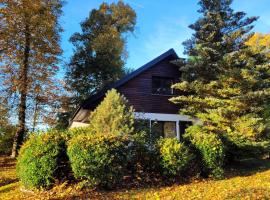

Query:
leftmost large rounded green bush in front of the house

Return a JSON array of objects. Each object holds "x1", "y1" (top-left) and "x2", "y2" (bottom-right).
[{"x1": 16, "y1": 131, "x2": 68, "y2": 188}]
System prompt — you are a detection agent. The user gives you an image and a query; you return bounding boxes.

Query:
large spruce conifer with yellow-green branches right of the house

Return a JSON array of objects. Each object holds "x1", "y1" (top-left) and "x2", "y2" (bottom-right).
[{"x1": 171, "y1": 0, "x2": 270, "y2": 158}]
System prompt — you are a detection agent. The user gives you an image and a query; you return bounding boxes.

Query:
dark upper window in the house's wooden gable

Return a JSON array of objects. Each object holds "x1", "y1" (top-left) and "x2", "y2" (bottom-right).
[{"x1": 152, "y1": 76, "x2": 173, "y2": 95}]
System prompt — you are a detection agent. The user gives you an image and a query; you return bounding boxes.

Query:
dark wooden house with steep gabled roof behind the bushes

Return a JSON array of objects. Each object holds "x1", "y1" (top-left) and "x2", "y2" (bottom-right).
[{"x1": 70, "y1": 49, "x2": 195, "y2": 139}]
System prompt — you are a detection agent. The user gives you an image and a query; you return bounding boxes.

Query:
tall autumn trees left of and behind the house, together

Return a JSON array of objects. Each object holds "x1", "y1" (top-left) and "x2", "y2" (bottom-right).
[{"x1": 0, "y1": 0, "x2": 136, "y2": 157}]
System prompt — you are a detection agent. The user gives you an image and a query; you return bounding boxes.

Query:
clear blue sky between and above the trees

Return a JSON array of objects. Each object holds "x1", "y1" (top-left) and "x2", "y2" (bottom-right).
[{"x1": 61, "y1": 0, "x2": 270, "y2": 69}]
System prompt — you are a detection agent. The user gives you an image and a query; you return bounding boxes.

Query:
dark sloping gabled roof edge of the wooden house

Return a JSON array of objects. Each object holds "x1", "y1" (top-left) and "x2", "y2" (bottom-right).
[{"x1": 72, "y1": 49, "x2": 179, "y2": 119}]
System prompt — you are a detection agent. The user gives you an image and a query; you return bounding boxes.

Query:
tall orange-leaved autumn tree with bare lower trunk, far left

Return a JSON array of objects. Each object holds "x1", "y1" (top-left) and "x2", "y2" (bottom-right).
[{"x1": 0, "y1": 0, "x2": 63, "y2": 157}]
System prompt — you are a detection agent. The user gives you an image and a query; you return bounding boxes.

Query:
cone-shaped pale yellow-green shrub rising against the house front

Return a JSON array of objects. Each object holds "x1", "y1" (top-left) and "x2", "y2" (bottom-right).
[{"x1": 89, "y1": 89, "x2": 134, "y2": 135}]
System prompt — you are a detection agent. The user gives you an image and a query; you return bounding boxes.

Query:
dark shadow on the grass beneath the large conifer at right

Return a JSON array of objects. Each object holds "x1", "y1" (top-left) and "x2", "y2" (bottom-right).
[{"x1": 226, "y1": 158, "x2": 270, "y2": 178}]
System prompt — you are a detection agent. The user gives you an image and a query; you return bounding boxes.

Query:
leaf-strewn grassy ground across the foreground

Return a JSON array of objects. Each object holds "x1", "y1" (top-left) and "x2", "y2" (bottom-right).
[{"x1": 0, "y1": 156, "x2": 270, "y2": 200}]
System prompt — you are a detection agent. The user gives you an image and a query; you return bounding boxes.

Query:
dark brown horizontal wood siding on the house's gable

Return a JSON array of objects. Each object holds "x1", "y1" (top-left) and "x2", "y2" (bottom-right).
[{"x1": 117, "y1": 59, "x2": 180, "y2": 114}]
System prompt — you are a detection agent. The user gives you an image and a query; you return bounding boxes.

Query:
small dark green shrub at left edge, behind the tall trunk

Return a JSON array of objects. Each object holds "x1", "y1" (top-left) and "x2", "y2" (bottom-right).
[{"x1": 0, "y1": 125, "x2": 16, "y2": 155}]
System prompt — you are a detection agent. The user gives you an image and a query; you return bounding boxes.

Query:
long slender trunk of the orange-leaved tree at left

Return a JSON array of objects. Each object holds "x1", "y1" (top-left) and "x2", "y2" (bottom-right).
[{"x1": 11, "y1": 22, "x2": 30, "y2": 158}]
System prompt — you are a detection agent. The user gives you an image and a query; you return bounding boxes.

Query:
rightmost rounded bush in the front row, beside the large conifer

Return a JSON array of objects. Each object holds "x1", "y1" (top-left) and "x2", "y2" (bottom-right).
[{"x1": 184, "y1": 125, "x2": 225, "y2": 179}]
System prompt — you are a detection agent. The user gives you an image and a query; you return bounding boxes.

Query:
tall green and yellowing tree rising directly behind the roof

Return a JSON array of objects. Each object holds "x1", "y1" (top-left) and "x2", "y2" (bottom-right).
[{"x1": 66, "y1": 1, "x2": 136, "y2": 105}]
